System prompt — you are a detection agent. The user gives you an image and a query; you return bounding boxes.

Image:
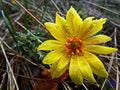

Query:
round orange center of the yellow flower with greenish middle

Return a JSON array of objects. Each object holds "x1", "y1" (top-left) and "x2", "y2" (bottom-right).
[{"x1": 65, "y1": 36, "x2": 85, "y2": 56}]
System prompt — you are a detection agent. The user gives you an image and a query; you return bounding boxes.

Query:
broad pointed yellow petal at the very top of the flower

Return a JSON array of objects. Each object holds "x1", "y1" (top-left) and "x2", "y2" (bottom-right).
[{"x1": 66, "y1": 7, "x2": 82, "y2": 35}]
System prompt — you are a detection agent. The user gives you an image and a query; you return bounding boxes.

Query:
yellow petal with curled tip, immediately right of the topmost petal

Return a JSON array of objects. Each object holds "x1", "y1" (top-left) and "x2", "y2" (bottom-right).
[{"x1": 79, "y1": 17, "x2": 94, "y2": 38}]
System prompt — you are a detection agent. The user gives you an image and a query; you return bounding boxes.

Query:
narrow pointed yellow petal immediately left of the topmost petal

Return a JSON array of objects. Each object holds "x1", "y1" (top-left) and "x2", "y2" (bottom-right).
[{"x1": 56, "y1": 13, "x2": 71, "y2": 38}]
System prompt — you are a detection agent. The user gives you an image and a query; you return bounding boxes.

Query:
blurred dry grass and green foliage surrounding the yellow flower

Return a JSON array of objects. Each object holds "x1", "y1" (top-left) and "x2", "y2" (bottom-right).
[{"x1": 0, "y1": 0, "x2": 120, "y2": 90}]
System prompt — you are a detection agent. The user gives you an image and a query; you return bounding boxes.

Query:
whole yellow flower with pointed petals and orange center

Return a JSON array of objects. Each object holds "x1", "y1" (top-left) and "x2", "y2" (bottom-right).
[{"x1": 38, "y1": 7, "x2": 117, "y2": 84}]
